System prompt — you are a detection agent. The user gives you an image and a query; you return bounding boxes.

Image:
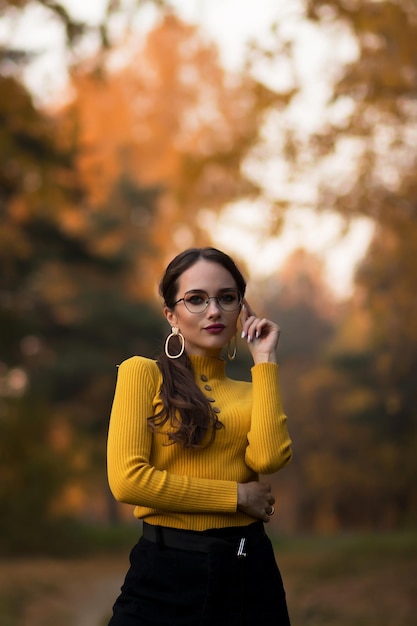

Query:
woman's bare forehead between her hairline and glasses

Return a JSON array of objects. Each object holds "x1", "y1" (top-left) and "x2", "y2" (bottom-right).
[{"x1": 178, "y1": 259, "x2": 237, "y2": 293}]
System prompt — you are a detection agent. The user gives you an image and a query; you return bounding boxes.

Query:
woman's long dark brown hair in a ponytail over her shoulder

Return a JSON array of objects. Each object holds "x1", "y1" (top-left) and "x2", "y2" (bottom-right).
[{"x1": 148, "y1": 247, "x2": 246, "y2": 448}]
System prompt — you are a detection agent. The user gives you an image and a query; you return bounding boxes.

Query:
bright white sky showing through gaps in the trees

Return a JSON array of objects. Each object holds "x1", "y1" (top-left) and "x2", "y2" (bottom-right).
[{"x1": 0, "y1": 0, "x2": 372, "y2": 298}]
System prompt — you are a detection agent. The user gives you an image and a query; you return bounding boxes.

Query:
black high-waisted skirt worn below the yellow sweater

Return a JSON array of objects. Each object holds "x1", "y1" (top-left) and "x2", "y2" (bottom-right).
[{"x1": 109, "y1": 522, "x2": 290, "y2": 626}]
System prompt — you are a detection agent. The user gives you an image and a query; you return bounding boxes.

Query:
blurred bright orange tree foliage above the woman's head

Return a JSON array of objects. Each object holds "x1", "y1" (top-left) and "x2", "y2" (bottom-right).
[{"x1": 63, "y1": 15, "x2": 267, "y2": 246}]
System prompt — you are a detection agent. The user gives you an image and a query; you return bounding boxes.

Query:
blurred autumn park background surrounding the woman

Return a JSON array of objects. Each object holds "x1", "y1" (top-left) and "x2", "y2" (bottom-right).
[{"x1": 0, "y1": 0, "x2": 417, "y2": 626}]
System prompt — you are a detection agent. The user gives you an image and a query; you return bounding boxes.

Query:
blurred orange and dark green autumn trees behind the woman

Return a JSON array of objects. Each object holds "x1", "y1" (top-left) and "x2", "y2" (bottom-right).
[{"x1": 0, "y1": 0, "x2": 417, "y2": 550}]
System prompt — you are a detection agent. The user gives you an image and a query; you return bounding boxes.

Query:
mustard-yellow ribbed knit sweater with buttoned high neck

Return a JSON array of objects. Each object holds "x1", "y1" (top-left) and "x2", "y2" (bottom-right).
[{"x1": 107, "y1": 356, "x2": 292, "y2": 530}]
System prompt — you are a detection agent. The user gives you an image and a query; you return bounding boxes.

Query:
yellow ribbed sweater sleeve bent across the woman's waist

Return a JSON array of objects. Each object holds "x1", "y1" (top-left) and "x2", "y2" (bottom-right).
[{"x1": 107, "y1": 357, "x2": 237, "y2": 513}]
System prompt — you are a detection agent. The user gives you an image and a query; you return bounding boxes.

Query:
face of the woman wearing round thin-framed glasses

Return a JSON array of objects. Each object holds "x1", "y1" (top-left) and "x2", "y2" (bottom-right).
[{"x1": 164, "y1": 259, "x2": 240, "y2": 357}]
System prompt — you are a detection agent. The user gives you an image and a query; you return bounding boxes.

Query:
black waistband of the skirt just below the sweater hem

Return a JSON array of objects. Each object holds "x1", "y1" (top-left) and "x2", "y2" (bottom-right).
[{"x1": 142, "y1": 522, "x2": 265, "y2": 557}]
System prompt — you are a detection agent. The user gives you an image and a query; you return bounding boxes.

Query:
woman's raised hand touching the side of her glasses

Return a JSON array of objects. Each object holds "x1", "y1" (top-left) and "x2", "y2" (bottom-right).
[{"x1": 240, "y1": 299, "x2": 281, "y2": 364}]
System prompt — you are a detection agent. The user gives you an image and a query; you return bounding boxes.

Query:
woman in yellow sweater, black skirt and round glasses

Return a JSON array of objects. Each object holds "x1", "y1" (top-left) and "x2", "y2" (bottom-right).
[{"x1": 108, "y1": 248, "x2": 291, "y2": 626}]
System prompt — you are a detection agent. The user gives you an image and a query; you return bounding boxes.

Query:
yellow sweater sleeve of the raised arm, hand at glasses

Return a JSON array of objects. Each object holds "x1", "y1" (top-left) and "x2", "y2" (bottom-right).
[{"x1": 245, "y1": 363, "x2": 292, "y2": 474}]
